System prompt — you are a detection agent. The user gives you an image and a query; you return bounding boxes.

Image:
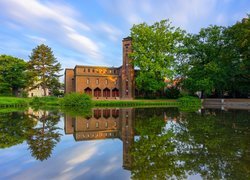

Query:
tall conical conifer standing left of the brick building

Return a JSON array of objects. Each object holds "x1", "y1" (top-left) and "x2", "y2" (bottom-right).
[{"x1": 28, "y1": 44, "x2": 61, "y2": 96}]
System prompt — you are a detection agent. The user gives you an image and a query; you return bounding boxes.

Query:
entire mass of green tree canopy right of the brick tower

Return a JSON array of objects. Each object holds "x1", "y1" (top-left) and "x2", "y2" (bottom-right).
[{"x1": 130, "y1": 15, "x2": 250, "y2": 97}]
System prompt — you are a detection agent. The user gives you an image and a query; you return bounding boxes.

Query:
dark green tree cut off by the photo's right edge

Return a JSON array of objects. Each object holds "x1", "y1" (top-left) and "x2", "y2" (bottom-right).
[{"x1": 224, "y1": 15, "x2": 250, "y2": 97}]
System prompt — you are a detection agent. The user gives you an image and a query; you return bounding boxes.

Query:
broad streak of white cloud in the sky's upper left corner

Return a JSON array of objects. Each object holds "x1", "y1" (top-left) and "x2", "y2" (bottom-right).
[{"x1": 0, "y1": 0, "x2": 101, "y2": 60}]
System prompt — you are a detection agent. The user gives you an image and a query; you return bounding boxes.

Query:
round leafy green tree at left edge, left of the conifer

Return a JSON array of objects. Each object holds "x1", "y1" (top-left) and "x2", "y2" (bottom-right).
[{"x1": 0, "y1": 55, "x2": 31, "y2": 96}]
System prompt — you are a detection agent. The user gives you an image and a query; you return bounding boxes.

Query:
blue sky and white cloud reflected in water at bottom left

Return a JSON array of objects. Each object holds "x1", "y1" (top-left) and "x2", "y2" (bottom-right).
[{"x1": 3, "y1": 138, "x2": 130, "y2": 179}]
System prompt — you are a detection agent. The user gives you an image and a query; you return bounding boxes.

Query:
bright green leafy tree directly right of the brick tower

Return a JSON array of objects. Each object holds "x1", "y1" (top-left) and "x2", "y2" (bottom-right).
[{"x1": 130, "y1": 20, "x2": 184, "y2": 92}]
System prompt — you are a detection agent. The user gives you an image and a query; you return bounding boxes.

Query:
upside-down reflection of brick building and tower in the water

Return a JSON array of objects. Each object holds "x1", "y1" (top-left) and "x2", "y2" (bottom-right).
[{"x1": 64, "y1": 108, "x2": 135, "y2": 169}]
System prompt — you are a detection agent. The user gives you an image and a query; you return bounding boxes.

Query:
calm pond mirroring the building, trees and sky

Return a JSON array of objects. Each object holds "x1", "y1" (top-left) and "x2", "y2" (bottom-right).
[{"x1": 0, "y1": 108, "x2": 250, "y2": 179}]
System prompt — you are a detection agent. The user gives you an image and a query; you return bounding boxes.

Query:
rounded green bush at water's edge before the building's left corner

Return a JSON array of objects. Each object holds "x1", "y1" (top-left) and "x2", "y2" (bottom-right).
[{"x1": 61, "y1": 93, "x2": 92, "y2": 107}]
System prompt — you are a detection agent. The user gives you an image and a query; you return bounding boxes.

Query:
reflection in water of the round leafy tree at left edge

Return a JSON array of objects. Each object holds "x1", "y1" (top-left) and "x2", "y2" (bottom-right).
[{"x1": 0, "y1": 111, "x2": 35, "y2": 148}]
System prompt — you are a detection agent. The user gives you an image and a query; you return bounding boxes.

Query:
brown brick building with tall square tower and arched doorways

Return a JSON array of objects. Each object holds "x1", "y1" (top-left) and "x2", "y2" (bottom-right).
[{"x1": 64, "y1": 37, "x2": 135, "y2": 99}]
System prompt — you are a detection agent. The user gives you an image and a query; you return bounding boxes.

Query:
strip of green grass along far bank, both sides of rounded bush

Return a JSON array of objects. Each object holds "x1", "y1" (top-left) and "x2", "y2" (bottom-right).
[{"x1": 0, "y1": 97, "x2": 201, "y2": 109}]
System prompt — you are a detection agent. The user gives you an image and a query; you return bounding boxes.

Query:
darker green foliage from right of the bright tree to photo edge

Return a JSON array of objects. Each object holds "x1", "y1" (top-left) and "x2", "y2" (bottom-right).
[{"x1": 176, "y1": 16, "x2": 250, "y2": 97}]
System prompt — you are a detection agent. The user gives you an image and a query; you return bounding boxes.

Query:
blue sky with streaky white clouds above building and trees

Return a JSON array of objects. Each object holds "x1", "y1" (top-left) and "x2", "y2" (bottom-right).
[{"x1": 0, "y1": 0, "x2": 250, "y2": 73}]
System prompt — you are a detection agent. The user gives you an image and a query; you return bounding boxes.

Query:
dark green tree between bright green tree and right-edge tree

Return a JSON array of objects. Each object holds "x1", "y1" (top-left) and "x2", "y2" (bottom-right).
[{"x1": 177, "y1": 26, "x2": 228, "y2": 97}]
